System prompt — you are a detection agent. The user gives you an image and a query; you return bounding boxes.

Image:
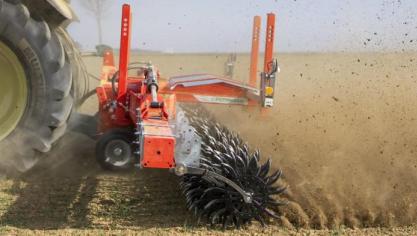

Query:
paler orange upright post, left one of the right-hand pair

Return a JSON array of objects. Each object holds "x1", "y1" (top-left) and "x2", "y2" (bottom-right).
[{"x1": 249, "y1": 16, "x2": 261, "y2": 87}]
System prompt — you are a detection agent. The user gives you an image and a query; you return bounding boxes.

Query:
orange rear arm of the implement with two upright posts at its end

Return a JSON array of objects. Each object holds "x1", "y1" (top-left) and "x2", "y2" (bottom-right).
[{"x1": 165, "y1": 13, "x2": 275, "y2": 107}]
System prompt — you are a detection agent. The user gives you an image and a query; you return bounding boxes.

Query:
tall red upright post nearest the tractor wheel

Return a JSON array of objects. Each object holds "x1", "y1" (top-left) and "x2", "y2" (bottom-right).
[{"x1": 117, "y1": 4, "x2": 132, "y2": 99}]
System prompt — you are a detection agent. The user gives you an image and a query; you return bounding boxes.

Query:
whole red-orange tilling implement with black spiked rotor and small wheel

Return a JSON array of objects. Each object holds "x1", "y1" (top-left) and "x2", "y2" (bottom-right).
[{"x1": 96, "y1": 5, "x2": 285, "y2": 227}]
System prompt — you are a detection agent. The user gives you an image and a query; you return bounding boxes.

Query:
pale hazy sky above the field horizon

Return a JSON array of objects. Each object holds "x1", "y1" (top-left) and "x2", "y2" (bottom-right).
[{"x1": 69, "y1": 0, "x2": 417, "y2": 52}]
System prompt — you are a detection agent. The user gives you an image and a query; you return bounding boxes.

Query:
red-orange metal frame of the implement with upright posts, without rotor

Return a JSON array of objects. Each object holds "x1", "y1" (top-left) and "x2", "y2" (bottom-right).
[{"x1": 96, "y1": 4, "x2": 275, "y2": 171}]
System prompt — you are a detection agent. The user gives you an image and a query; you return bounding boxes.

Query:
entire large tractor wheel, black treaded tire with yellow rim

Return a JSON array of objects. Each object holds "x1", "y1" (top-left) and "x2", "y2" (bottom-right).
[{"x1": 0, "y1": 0, "x2": 74, "y2": 171}]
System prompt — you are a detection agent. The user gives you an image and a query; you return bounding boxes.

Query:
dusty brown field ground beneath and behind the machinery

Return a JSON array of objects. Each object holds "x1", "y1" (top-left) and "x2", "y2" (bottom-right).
[{"x1": 0, "y1": 53, "x2": 417, "y2": 235}]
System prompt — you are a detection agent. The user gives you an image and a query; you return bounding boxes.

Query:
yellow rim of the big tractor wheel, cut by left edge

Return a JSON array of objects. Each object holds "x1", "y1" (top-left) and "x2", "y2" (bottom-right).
[{"x1": 0, "y1": 41, "x2": 28, "y2": 141}]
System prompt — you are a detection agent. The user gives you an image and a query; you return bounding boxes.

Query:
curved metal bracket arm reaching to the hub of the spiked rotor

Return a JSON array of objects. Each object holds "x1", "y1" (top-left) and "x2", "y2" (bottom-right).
[{"x1": 174, "y1": 165, "x2": 253, "y2": 204}]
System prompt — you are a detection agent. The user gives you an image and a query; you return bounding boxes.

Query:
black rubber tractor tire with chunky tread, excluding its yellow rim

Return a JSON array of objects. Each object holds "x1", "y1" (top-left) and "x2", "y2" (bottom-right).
[{"x1": 0, "y1": 0, "x2": 88, "y2": 171}]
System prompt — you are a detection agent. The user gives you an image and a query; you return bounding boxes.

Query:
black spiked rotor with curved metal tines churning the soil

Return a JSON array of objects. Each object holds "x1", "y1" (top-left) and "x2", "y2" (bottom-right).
[{"x1": 181, "y1": 106, "x2": 285, "y2": 228}]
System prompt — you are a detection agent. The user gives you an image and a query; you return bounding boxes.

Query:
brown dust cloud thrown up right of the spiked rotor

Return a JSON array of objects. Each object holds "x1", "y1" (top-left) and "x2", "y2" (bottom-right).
[{"x1": 210, "y1": 53, "x2": 417, "y2": 228}]
